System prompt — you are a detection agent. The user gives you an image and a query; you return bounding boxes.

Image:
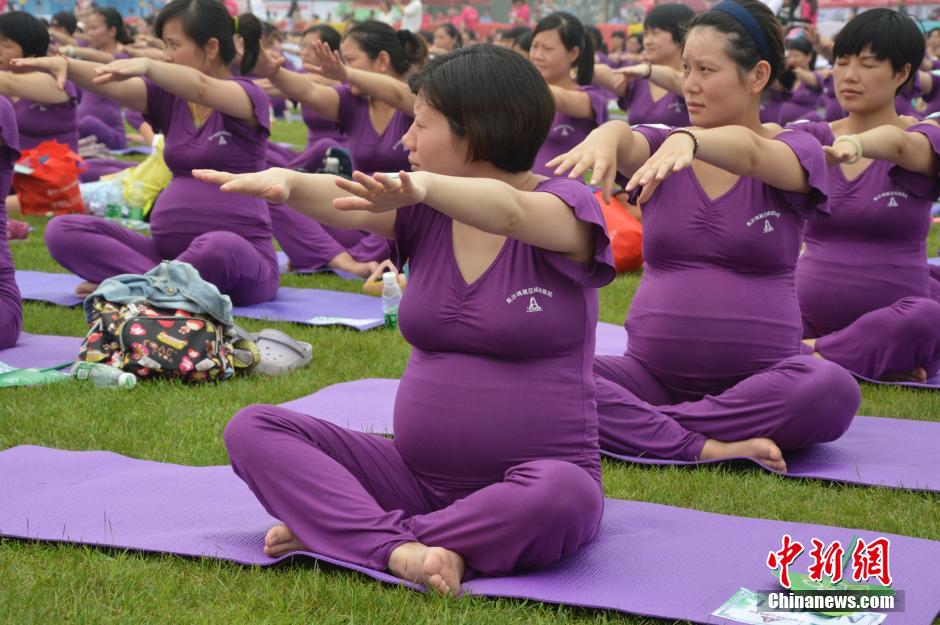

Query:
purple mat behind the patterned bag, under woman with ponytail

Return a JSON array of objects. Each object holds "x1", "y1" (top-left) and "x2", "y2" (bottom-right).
[{"x1": 16, "y1": 270, "x2": 384, "y2": 330}]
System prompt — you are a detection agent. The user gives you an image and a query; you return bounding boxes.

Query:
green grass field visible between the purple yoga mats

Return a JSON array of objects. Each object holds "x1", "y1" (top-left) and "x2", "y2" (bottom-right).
[{"x1": 0, "y1": 118, "x2": 940, "y2": 625}]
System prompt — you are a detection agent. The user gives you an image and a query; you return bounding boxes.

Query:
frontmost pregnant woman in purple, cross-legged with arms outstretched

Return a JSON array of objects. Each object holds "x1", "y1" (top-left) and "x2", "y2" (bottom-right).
[{"x1": 194, "y1": 45, "x2": 615, "y2": 594}]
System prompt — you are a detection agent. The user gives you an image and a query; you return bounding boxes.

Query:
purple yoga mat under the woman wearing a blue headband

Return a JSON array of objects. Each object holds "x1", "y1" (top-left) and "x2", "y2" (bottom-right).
[{"x1": 281, "y1": 379, "x2": 940, "y2": 492}]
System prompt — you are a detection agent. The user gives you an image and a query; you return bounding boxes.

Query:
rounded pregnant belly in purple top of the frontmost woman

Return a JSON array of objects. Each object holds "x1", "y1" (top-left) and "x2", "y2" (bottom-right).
[{"x1": 395, "y1": 349, "x2": 597, "y2": 490}]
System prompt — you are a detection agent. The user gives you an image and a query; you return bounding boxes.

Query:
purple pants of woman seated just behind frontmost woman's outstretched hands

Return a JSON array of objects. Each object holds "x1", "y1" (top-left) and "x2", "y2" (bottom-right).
[{"x1": 268, "y1": 204, "x2": 390, "y2": 269}]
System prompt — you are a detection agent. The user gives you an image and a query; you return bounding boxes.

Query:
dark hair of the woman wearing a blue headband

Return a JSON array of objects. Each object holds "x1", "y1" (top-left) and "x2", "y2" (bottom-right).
[{"x1": 684, "y1": 0, "x2": 796, "y2": 91}]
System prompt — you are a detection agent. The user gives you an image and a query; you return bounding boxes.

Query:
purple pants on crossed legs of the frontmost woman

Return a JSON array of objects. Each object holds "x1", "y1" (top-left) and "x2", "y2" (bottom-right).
[{"x1": 225, "y1": 405, "x2": 604, "y2": 575}]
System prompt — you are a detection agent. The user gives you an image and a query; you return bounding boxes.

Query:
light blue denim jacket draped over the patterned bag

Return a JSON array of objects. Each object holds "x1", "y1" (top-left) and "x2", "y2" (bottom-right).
[{"x1": 84, "y1": 260, "x2": 235, "y2": 327}]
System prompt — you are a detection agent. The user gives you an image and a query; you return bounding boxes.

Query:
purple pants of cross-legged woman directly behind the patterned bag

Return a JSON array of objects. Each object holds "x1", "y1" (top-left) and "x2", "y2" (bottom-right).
[{"x1": 46, "y1": 215, "x2": 280, "y2": 306}]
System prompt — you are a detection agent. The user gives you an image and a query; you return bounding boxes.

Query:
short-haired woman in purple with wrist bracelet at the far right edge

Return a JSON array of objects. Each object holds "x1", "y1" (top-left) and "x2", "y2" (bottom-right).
[{"x1": 790, "y1": 9, "x2": 940, "y2": 382}]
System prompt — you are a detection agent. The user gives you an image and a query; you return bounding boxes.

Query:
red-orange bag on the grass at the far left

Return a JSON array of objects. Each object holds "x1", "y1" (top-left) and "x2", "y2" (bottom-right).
[{"x1": 13, "y1": 141, "x2": 87, "y2": 215}]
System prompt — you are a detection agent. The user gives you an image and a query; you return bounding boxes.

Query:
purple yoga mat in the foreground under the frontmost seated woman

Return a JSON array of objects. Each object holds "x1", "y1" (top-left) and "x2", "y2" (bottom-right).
[{"x1": 0, "y1": 446, "x2": 940, "y2": 625}]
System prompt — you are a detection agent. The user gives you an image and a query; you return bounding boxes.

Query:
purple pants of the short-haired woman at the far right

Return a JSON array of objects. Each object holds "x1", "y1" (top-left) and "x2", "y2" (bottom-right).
[{"x1": 804, "y1": 297, "x2": 940, "y2": 380}]
